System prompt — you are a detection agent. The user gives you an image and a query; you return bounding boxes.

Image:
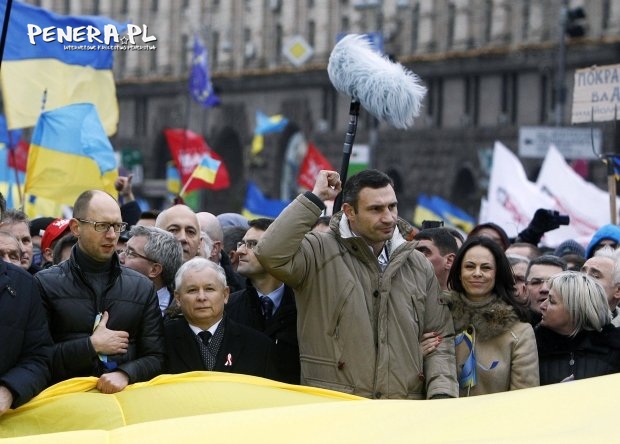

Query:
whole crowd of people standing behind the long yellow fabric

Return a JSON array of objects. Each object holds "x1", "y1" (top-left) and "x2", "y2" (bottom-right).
[{"x1": 0, "y1": 170, "x2": 620, "y2": 421}]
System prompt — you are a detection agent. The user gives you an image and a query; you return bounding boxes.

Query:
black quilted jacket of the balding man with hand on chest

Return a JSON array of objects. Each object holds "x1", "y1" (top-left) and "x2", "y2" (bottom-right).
[{"x1": 35, "y1": 245, "x2": 165, "y2": 384}]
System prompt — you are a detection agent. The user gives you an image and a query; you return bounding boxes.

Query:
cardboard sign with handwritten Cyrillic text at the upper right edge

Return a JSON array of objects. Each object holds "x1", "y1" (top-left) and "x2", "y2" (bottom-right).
[{"x1": 571, "y1": 64, "x2": 620, "y2": 124}]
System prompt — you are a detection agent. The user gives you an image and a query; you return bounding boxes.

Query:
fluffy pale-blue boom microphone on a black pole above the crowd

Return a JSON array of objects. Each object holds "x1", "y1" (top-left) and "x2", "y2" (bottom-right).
[{"x1": 327, "y1": 34, "x2": 426, "y2": 213}]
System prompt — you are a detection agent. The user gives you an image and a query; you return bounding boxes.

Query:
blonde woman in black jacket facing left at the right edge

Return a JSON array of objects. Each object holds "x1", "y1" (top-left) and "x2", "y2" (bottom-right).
[{"x1": 535, "y1": 271, "x2": 620, "y2": 385}]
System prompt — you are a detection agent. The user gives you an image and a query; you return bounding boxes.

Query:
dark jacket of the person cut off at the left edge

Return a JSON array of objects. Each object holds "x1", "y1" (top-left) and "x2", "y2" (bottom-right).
[{"x1": 0, "y1": 261, "x2": 52, "y2": 408}]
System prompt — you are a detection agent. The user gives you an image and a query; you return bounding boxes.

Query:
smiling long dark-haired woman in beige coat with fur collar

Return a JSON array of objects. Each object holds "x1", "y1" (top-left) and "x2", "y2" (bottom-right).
[{"x1": 422, "y1": 236, "x2": 539, "y2": 396}]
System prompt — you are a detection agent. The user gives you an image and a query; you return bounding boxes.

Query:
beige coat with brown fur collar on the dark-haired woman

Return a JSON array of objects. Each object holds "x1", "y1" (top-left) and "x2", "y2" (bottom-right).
[{"x1": 448, "y1": 292, "x2": 540, "y2": 396}]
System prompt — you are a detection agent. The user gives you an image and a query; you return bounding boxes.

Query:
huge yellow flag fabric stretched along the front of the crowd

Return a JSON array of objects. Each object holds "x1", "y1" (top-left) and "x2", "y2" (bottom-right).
[{"x1": 0, "y1": 372, "x2": 620, "y2": 444}]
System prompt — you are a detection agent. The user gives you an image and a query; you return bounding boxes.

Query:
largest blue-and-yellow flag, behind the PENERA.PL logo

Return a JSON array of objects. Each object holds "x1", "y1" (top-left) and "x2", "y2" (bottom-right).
[{"x1": 0, "y1": 0, "x2": 126, "y2": 135}]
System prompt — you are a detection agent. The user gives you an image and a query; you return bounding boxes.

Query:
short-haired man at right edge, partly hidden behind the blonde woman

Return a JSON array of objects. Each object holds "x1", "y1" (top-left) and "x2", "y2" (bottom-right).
[{"x1": 581, "y1": 246, "x2": 620, "y2": 327}]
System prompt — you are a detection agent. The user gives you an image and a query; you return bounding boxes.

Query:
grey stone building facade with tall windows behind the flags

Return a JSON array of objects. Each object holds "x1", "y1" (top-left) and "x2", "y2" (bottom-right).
[{"x1": 26, "y1": 0, "x2": 620, "y2": 218}]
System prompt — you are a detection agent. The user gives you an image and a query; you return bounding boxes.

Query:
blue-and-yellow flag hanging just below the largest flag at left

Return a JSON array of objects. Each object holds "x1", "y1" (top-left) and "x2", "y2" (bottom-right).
[{"x1": 26, "y1": 103, "x2": 118, "y2": 205}]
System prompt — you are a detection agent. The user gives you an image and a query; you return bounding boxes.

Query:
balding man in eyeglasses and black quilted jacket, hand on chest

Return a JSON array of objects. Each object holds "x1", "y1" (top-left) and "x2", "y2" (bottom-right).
[{"x1": 35, "y1": 190, "x2": 164, "y2": 393}]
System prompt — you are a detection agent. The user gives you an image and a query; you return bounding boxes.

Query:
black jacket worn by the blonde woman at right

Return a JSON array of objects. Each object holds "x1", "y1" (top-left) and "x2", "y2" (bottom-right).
[{"x1": 534, "y1": 324, "x2": 620, "y2": 385}]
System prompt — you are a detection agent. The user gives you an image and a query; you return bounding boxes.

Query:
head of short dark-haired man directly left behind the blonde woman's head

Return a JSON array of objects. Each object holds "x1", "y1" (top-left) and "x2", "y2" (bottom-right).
[{"x1": 525, "y1": 254, "x2": 566, "y2": 325}]
